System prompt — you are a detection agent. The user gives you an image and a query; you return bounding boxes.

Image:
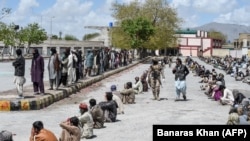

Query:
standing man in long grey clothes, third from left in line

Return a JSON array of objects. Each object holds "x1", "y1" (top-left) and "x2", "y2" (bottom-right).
[{"x1": 48, "y1": 48, "x2": 60, "y2": 90}]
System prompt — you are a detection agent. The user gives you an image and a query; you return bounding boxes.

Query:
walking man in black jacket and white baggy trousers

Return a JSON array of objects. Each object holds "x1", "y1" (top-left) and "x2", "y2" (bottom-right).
[{"x1": 172, "y1": 58, "x2": 189, "y2": 101}]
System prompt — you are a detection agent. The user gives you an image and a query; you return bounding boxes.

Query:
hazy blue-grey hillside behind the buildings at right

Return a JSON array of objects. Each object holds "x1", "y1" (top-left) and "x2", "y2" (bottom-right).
[{"x1": 192, "y1": 22, "x2": 250, "y2": 42}]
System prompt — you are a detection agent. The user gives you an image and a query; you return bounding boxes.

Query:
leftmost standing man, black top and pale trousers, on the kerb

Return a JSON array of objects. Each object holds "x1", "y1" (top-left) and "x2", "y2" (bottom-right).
[{"x1": 12, "y1": 49, "x2": 26, "y2": 98}]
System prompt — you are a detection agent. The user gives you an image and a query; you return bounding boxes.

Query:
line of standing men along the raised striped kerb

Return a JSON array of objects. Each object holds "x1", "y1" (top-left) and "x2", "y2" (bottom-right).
[{"x1": 13, "y1": 48, "x2": 134, "y2": 98}]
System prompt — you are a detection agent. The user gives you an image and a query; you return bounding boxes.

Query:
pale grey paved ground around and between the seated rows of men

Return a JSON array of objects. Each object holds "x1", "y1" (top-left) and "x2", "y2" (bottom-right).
[{"x1": 0, "y1": 56, "x2": 250, "y2": 141}]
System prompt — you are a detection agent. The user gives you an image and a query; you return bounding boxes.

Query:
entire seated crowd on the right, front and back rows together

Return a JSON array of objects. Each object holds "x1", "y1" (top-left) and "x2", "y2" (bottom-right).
[{"x1": 186, "y1": 56, "x2": 250, "y2": 125}]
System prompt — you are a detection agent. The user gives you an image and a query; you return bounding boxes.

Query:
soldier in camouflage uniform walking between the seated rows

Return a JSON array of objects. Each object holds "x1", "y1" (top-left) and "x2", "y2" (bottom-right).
[{"x1": 148, "y1": 59, "x2": 165, "y2": 101}]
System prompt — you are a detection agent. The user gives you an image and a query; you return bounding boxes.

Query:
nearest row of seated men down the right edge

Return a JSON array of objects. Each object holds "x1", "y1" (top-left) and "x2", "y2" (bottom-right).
[{"x1": 193, "y1": 56, "x2": 250, "y2": 125}]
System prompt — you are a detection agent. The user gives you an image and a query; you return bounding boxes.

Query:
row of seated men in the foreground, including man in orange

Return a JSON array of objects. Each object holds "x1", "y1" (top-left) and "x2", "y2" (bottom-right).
[{"x1": 21, "y1": 66, "x2": 149, "y2": 141}]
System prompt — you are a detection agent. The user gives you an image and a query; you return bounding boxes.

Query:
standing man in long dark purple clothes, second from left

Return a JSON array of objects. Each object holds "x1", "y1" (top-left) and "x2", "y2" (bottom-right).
[{"x1": 30, "y1": 48, "x2": 44, "y2": 95}]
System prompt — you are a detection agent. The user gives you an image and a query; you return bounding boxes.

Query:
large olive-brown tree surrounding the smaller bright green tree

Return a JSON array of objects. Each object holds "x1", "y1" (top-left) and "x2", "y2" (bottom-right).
[{"x1": 112, "y1": 0, "x2": 182, "y2": 54}]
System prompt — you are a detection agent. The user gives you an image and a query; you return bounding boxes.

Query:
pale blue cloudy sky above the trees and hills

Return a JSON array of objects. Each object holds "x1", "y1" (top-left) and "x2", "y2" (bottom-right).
[{"x1": 0, "y1": 0, "x2": 250, "y2": 40}]
